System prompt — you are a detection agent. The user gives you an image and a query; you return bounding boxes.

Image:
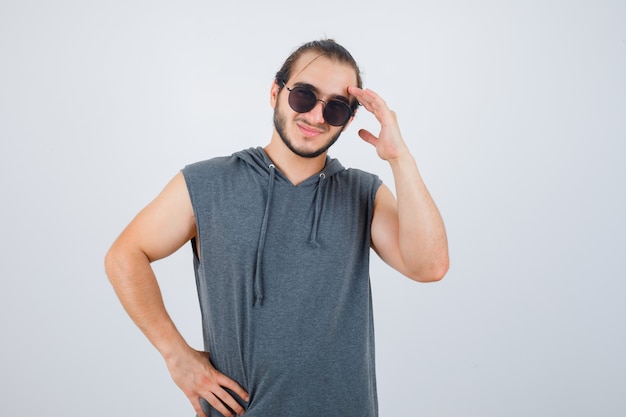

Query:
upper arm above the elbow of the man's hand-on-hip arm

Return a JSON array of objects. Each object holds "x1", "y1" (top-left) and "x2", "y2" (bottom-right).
[{"x1": 117, "y1": 172, "x2": 196, "y2": 262}]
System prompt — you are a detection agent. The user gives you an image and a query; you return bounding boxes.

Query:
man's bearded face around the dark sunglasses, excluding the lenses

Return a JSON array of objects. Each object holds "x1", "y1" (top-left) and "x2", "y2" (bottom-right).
[{"x1": 272, "y1": 53, "x2": 356, "y2": 158}]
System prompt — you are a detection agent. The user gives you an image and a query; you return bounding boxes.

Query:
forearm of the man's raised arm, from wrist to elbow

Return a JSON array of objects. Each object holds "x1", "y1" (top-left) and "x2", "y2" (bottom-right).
[{"x1": 389, "y1": 151, "x2": 449, "y2": 281}]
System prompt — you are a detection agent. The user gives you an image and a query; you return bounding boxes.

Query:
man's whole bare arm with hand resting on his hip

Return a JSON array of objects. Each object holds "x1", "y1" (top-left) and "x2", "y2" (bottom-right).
[{"x1": 105, "y1": 173, "x2": 247, "y2": 416}]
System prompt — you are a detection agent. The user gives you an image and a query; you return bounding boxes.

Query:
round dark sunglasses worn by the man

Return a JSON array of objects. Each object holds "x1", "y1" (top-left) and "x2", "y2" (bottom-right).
[{"x1": 278, "y1": 80, "x2": 358, "y2": 126}]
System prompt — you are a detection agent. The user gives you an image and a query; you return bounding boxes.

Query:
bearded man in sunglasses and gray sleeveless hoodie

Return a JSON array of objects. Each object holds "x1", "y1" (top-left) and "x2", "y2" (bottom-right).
[{"x1": 106, "y1": 40, "x2": 448, "y2": 417}]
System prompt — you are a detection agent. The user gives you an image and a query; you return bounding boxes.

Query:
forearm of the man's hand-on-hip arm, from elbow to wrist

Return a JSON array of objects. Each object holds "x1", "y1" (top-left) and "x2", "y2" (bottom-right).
[{"x1": 105, "y1": 243, "x2": 189, "y2": 359}]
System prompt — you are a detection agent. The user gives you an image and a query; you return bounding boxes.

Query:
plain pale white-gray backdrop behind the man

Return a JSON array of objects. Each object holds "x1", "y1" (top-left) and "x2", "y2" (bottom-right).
[{"x1": 0, "y1": 0, "x2": 626, "y2": 417}]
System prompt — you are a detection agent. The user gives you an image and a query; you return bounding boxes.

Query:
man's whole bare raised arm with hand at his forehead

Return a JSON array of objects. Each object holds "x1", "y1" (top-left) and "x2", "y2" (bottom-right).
[{"x1": 349, "y1": 87, "x2": 449, "y2": 282}]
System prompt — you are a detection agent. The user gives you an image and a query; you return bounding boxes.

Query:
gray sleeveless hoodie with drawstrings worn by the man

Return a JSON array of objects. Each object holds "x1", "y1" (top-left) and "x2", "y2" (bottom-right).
[{"x1": 182, "y1": 148, "x2": 381, "y2": 417}]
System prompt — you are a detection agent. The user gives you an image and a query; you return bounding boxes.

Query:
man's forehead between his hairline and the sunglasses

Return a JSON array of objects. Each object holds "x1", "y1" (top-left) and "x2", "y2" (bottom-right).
[{"x1": 290, "y1": 52, "x2": 357, "y2": 96}]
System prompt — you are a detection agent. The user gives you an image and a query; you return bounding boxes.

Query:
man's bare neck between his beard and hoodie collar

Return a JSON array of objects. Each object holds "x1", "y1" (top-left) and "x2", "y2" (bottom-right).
[{"x1": 264, "y1": 132, "x2": 327, "y2": 185}]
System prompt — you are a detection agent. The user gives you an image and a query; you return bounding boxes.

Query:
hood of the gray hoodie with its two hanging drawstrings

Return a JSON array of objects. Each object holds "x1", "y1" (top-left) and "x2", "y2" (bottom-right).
[{"x1": 233, "y1": 147, "x2": 345, "y2": 306}]
